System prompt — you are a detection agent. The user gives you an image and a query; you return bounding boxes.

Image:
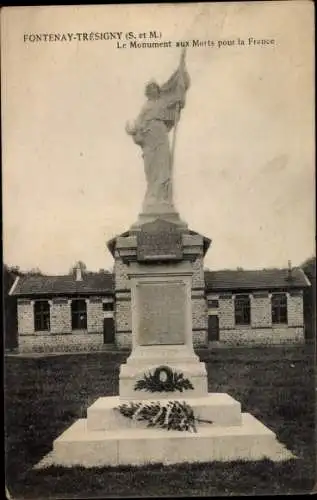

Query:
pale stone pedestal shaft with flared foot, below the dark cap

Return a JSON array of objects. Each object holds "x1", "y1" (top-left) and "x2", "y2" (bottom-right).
[{"x1": 119, "y1": 254, "x2": 208, "y2": 399}]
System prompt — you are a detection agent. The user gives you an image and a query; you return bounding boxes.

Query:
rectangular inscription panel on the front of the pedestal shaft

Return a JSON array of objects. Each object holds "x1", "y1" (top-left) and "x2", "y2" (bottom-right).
[{"x1": 137, "y1": 282, "x2": 187, "y2": 345}]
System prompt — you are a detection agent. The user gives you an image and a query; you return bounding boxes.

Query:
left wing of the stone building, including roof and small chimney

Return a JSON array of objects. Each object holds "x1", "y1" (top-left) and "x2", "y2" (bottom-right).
[{"x1": 10, "y1": 269, "x2": 115, "y2": 352}]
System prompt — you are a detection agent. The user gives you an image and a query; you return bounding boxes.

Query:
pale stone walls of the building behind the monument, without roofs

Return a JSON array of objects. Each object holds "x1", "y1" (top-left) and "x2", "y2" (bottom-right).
[{"x1": 17, "y1": 286, "x2": 304, "y2": 352}]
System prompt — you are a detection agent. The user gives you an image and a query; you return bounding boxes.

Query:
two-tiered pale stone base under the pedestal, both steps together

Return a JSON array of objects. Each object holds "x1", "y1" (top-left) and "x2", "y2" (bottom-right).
[{"x1": 35, "y1": 394, "x2": 295, "y2": 469}]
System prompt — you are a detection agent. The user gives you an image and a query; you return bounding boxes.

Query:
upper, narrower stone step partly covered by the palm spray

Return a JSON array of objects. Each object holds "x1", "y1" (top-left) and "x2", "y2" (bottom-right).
[{"x1": 87, "y1": 393, "x2": 241, "y2": 431}]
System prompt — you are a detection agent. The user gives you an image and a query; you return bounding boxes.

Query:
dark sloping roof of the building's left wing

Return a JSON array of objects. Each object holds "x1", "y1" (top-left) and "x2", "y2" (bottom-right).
[{"x1": 10, "y1": 273, "x2": 114, "y2": 296}]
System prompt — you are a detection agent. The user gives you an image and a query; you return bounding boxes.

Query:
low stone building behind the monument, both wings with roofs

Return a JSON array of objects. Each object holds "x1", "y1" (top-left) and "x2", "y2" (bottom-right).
[{"x1": 10, "y1": 263, "x2": 310, "y2": 352}]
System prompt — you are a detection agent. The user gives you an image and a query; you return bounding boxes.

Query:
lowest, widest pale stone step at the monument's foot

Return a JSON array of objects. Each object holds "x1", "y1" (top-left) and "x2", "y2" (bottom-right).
[{"x1": 47, "y1": 413, "x2": 293, "y2": 468}]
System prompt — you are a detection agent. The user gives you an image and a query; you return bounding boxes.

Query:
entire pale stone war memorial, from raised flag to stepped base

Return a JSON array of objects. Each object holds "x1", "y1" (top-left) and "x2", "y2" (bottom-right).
[{"x1": 38, "y1": 51, "x2": 292, "y2": 467}]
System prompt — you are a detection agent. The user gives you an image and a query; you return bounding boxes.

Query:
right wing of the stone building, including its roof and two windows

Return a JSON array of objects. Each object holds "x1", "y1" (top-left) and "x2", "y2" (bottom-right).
[{"x1": 205, "y1": 268, "x2": 310, "y2": 345}]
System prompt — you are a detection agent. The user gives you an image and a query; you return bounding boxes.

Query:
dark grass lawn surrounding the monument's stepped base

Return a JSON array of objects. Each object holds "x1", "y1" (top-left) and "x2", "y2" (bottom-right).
[{"x1": 5, "y1": 346, "x2": 316, "y2": 499}]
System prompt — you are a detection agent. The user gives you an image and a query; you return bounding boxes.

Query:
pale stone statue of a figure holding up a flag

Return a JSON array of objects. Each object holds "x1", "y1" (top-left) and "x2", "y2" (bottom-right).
[{"x1": 126, "y1": 50, "x2": 190, "y2": 212}]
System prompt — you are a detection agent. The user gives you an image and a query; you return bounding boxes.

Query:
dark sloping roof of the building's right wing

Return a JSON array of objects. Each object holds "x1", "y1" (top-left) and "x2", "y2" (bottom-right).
[{"x1": 205, "y1": 268, "x2": 310, "y2": 292}]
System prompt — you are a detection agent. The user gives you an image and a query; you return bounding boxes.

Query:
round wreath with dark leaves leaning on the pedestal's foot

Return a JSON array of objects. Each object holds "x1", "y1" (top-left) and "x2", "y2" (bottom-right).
[{"x1": 134, "y1": 366, "x2": 194, "y2": 392}]
